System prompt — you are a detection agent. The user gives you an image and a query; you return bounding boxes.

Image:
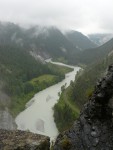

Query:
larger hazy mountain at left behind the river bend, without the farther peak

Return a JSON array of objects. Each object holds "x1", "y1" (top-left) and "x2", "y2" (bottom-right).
[{"x1": 0, "y1": 23, "x2": 79, "y2": 62}]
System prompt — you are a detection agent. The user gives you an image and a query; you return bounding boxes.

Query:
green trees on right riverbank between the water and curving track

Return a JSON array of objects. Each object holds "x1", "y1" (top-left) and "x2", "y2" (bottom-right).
[{"x1": 54, "y1": 81, "x2": 79, "y2": 132}]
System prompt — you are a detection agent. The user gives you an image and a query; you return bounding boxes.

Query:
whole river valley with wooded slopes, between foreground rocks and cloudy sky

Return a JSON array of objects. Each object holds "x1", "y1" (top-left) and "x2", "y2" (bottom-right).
[{"x1": 0, "y1": 23, "x2": 113, "y2": 149}]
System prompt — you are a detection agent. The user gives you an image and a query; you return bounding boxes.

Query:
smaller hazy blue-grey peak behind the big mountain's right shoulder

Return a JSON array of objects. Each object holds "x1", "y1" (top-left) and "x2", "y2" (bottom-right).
[{"x1": 66, "y1": 31, "x2": 97, "y2": 51}]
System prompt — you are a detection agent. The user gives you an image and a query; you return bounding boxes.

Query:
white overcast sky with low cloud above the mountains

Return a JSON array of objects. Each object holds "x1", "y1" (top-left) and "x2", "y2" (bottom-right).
[{"x1": 0, "y1": 0, "x2": 113, "y2": 34}]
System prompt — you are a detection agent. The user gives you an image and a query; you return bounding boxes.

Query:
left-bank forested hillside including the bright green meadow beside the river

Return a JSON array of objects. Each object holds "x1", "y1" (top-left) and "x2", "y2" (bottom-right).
[{"x1": 0, "y1": 44, "x2": 71, "y2": 115}]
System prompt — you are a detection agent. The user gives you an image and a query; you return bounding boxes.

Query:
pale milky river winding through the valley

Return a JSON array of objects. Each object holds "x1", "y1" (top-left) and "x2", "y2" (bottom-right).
[{"x1": 15, "y1": 60, "x2": 80, "y2": 139}]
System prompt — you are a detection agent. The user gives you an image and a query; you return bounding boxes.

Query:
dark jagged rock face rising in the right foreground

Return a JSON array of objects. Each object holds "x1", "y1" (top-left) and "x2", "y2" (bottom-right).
[{"x1": 54, "y1": 65, "x2": 113, "y2": 150}]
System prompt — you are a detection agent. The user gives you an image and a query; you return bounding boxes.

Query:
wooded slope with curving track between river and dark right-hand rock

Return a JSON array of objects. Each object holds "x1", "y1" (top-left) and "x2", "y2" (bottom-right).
[{"x1": 54, "y1": 51, "x2": 113, "y2": 131}]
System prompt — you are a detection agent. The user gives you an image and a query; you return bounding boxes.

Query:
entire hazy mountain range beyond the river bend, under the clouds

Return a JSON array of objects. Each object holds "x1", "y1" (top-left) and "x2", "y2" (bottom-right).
[{"x1": 0, "y1": 22, "x2": 105, "y2": 64}]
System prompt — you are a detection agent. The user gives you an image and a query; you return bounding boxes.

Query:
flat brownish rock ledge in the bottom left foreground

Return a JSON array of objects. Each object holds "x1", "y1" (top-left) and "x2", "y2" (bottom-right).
[{"x1": 0, "y1": 129, "x2": 50, "y2": 150}]
